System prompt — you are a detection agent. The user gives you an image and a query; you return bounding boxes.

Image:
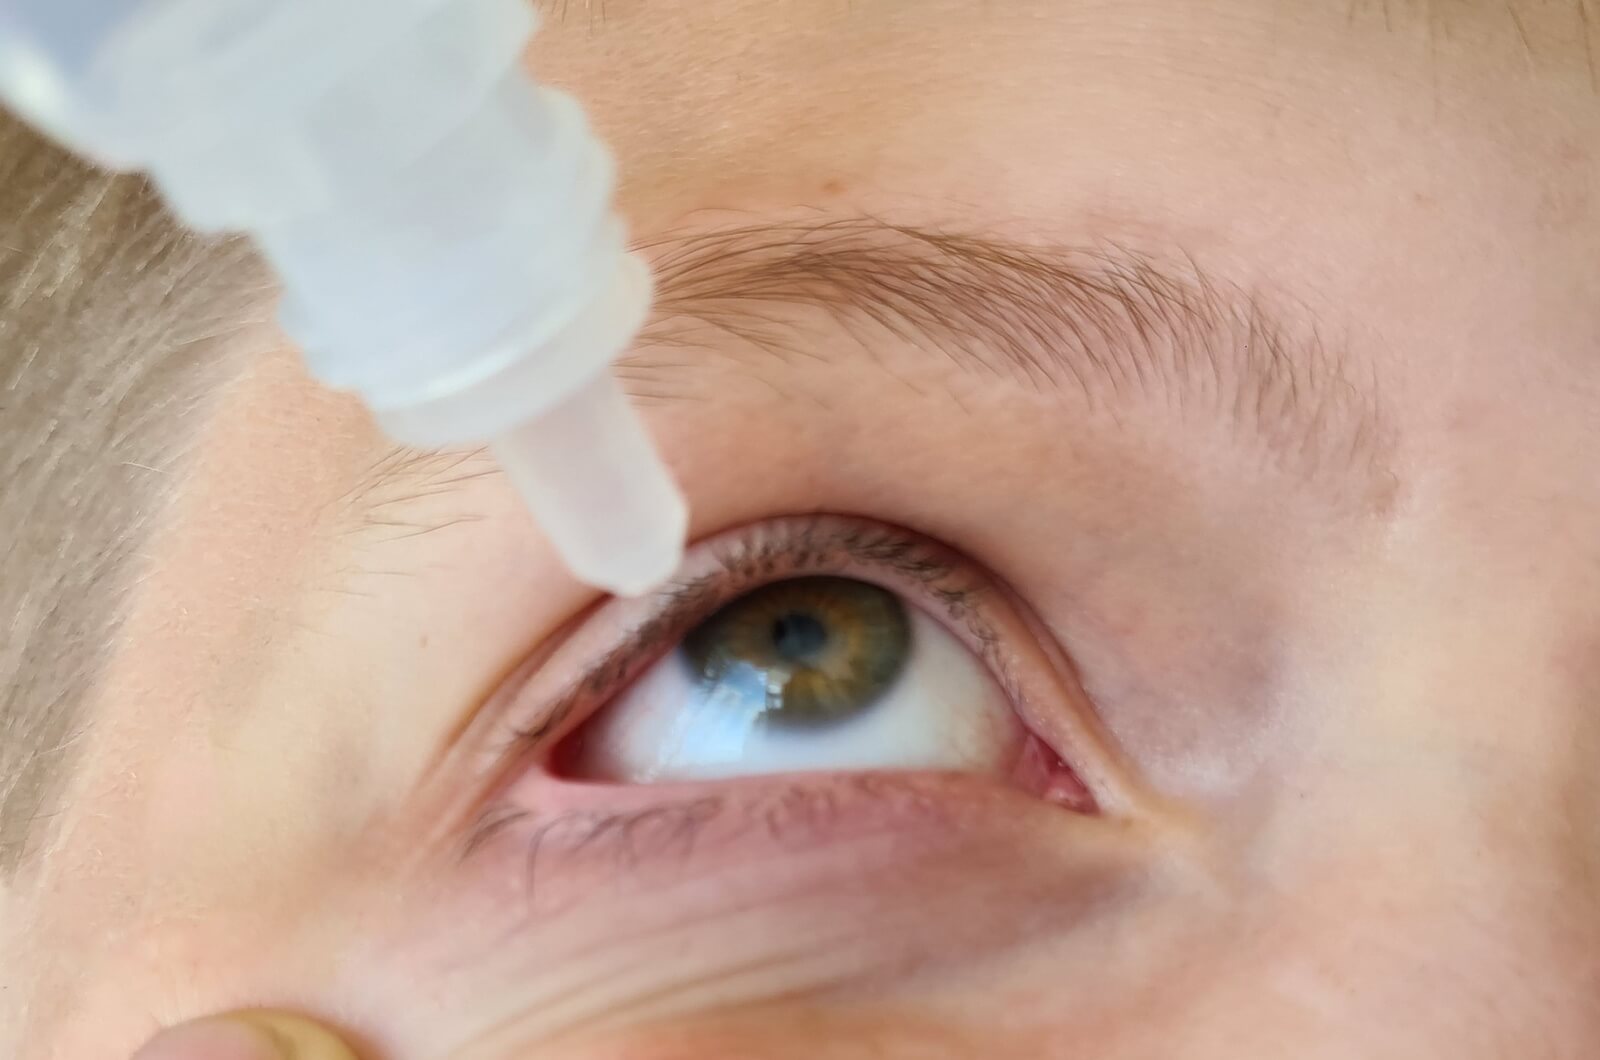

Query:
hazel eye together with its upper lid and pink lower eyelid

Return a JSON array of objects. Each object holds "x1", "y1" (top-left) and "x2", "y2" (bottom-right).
[{"x1": 432, "y1": 514, "x2": 1147, "y2": 1024}]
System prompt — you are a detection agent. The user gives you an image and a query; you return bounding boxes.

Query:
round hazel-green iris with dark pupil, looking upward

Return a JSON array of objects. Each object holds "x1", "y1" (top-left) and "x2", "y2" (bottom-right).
[{"x1": 683, "y1": 576, "x2": 910, "y2": 727}]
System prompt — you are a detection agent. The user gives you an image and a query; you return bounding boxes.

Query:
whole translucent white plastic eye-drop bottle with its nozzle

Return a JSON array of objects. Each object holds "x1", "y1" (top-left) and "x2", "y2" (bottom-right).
[{"x1": 0, "y1": 0, "x2": 688, "y2": 594}]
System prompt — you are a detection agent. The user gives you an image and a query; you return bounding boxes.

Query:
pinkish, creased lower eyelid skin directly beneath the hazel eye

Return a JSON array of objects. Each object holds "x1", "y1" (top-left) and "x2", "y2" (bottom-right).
[{"x1": 435, "y1": 770, "x2": 1152, "y2": 1024}]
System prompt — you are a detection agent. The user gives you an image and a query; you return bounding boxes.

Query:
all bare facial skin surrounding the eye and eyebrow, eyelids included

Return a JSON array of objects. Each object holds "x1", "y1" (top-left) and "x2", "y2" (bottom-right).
[{"x1": 0, "y1": 0, "x2": 1600, "y2": 1060}]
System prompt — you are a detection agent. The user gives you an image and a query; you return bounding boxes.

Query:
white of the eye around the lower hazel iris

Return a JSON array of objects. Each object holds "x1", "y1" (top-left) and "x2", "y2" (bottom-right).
[{"x1": 571, "y1": 607, "x2": 1024, "y2": 783}]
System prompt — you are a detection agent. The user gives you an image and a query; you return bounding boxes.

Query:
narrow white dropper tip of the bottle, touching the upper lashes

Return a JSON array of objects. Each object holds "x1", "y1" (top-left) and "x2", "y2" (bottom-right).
[{"x1": 490, "y1": 371, "x2": 688, "y2": 596}]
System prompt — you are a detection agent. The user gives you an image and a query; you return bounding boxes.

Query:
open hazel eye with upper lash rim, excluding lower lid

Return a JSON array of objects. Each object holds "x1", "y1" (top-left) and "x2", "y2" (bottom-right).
[{"x1": 512, "y1": 517, "x2": 1091, "y2": 809}]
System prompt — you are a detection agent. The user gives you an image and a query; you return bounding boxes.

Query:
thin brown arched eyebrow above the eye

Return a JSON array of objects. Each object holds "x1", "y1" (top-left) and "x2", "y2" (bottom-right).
[{"x1": 618, "y1": 216, "x2": 1395, "y2": 509}]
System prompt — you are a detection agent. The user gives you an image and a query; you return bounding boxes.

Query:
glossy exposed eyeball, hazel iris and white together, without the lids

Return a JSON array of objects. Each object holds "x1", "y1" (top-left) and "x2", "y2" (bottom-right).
[{"x1": 568, "y1": 576, "x2": 1024, "y2": 783}]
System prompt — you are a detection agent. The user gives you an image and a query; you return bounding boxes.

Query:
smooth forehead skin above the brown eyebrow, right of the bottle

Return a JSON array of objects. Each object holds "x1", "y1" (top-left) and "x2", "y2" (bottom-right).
[{"x1": 531, "y1": 0, "x2": 1600, "y2": 418}]
